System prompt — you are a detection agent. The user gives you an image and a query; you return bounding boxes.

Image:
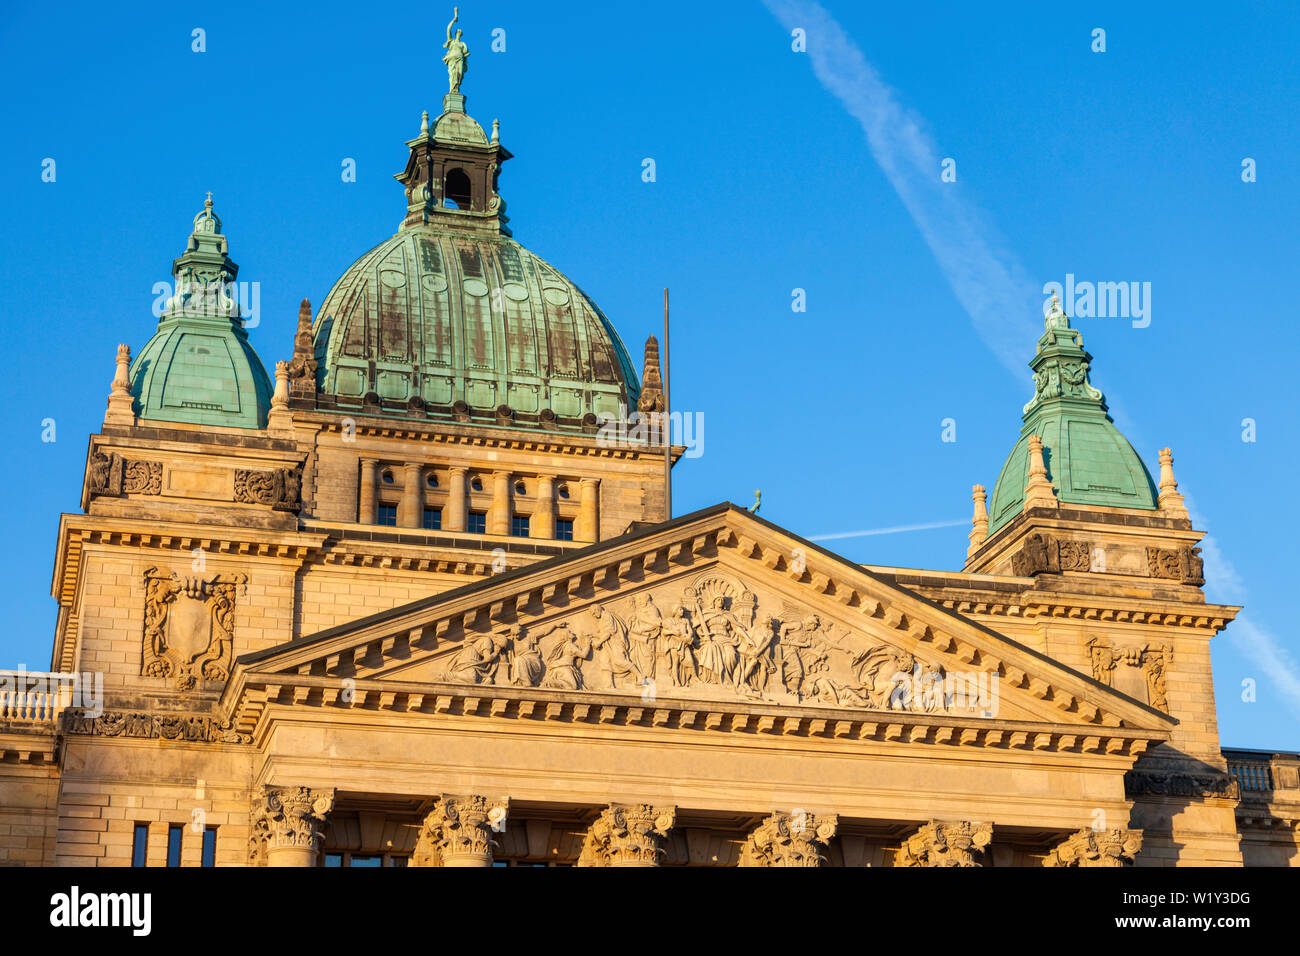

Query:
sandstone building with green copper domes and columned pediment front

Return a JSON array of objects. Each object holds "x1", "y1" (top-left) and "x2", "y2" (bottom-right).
[{"x1": 0, "y1": 57, "x2": 1300, "y2": 866}]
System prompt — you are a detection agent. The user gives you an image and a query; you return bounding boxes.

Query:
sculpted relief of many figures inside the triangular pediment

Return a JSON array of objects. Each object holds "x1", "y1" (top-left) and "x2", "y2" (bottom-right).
[{"x1": 434, "y1": 571, "x2": 996, "y2": 713}]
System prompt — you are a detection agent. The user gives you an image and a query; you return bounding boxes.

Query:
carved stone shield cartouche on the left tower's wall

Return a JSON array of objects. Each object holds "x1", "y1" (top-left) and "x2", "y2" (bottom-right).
[{"x1": 140, "y1": 567, "x2": 247, "y2": 691}]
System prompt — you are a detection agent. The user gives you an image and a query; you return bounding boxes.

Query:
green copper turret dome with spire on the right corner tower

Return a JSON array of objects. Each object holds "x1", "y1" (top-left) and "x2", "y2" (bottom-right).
[{"x1": 988, "y1": 297, "x2": 1157, "y2": 535}]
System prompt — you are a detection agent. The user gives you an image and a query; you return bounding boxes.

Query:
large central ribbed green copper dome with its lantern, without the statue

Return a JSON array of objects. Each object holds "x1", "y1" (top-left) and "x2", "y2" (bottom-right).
[{"x1": 313, "y1": 94, "x2": 640, "y2": 429}]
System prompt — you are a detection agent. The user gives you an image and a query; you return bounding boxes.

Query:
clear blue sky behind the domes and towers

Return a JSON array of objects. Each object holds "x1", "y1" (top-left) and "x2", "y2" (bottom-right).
[{"x1": 0, "y1": 0, "x2": 1300, "y2": 748}]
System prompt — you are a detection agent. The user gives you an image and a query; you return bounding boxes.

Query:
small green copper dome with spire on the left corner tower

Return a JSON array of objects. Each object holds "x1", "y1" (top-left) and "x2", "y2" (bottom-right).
[{"x1": 130, "y1": 194, "x2": 272, "y2": 428}]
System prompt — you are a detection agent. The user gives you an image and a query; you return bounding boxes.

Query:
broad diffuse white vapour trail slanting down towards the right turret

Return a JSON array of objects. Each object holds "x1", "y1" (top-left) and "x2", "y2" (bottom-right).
[{"x1": 763, "y1": 0, "x2": 1043, "y2": 377}]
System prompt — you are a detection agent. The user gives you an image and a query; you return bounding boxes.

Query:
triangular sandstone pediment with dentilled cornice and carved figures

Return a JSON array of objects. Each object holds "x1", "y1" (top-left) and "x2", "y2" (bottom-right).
[{"x1": 228, "y1": 506, "x2": 1173, "y2": 740}]
